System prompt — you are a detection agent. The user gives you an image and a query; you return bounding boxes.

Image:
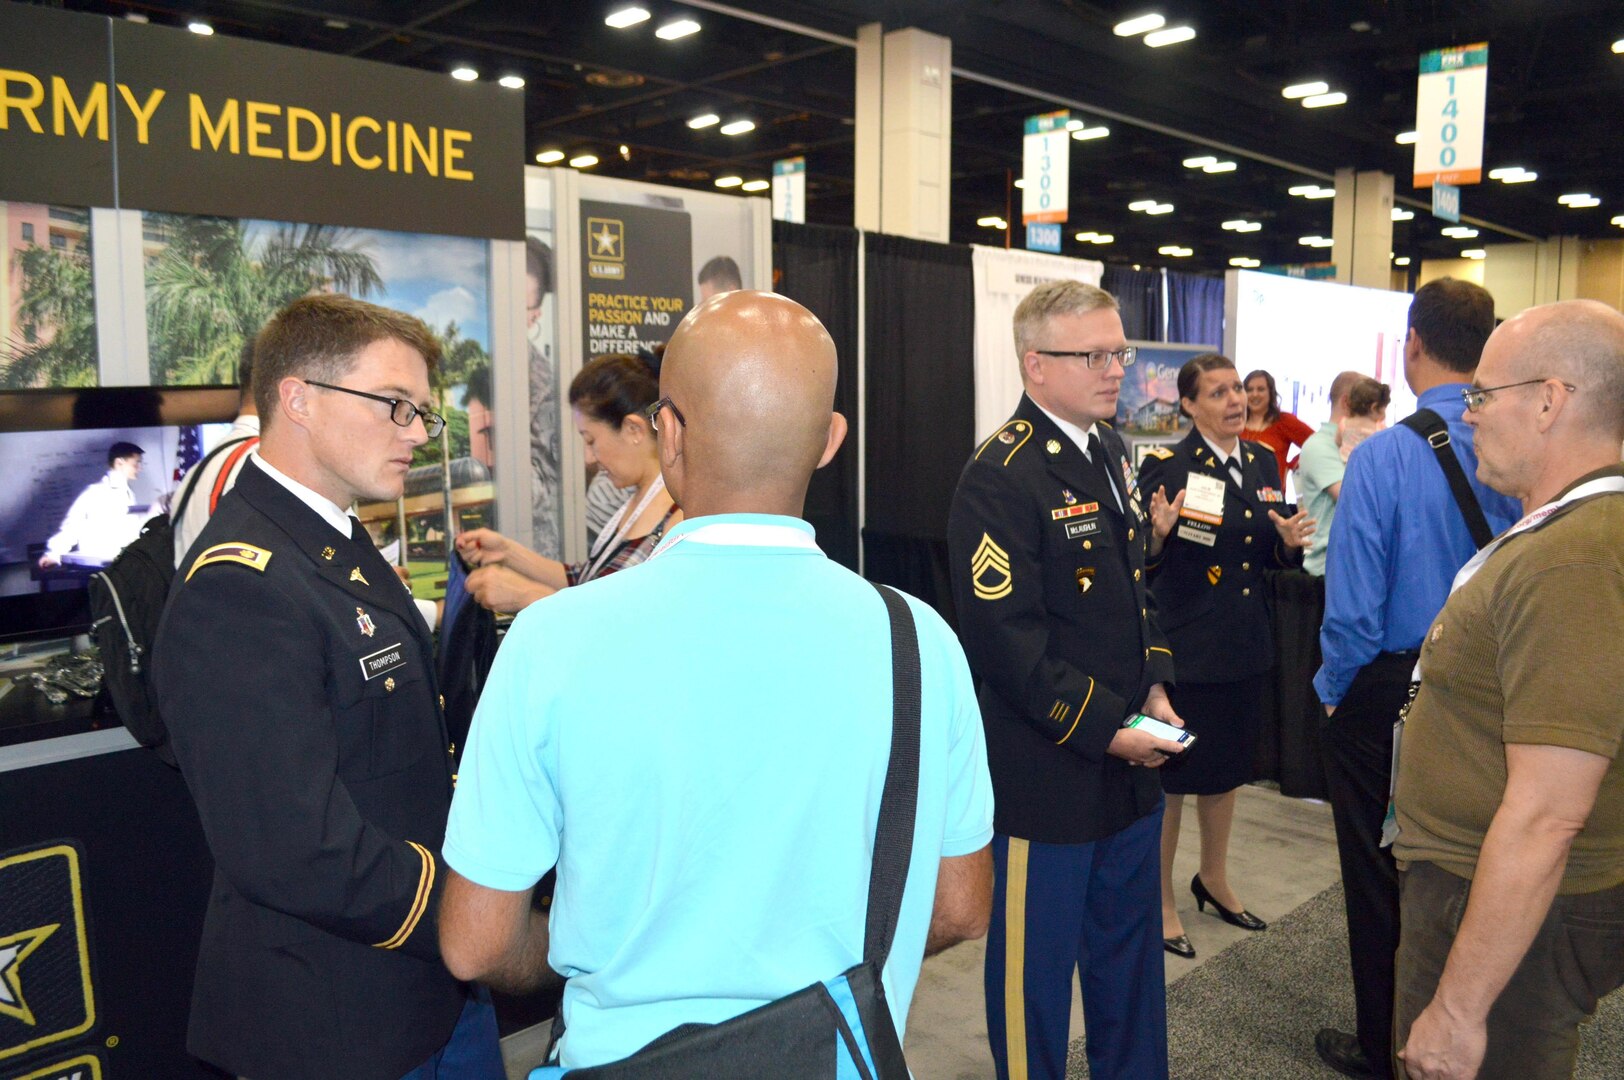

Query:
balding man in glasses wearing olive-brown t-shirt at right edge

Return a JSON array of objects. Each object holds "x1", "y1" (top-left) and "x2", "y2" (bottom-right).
[{"x1": 1393, "y1": 300, "x2": 1624, "y2": 1080}]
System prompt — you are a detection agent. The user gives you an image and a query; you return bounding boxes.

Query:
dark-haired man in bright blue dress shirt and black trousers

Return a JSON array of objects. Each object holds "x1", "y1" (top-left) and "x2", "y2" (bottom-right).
[{"x1": 1314, "y1": 278, "x2": 1520, "y2": 1077}]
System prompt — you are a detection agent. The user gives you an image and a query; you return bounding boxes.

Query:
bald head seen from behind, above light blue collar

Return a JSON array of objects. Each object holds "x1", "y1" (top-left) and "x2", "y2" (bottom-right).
[{"x1": 659, "y1": 291, "x2": 844, "y2": 516}]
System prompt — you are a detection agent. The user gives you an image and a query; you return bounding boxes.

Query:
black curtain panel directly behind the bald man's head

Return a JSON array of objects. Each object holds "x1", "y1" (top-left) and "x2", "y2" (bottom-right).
[{"x1": 773, "y1": 221, "x2": 861, "y2": 572}]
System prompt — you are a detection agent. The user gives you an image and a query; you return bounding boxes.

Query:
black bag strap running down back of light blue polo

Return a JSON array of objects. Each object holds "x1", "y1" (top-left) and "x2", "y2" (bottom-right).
[{"x1": 862, "y1": 585, "x2": 919, "y2": 971}]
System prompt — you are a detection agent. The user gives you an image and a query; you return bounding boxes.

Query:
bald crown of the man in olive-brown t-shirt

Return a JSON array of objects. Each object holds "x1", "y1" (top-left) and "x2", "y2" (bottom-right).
[{"x1": 1494, "y1": 300, "x2": 1624, "y2": 442}]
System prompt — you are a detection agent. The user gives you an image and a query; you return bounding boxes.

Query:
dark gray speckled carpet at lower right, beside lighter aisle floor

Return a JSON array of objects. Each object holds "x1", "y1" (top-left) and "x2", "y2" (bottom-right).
[{"x1": 1065, "y1": 883, "x2": 1624, "y2": 1080}]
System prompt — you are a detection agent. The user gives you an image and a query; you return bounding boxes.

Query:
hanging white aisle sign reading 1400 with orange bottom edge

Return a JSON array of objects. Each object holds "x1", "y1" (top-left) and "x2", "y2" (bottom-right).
[{"x1": 1415, "y1": 42, "x2": 1489, "y2": 187}]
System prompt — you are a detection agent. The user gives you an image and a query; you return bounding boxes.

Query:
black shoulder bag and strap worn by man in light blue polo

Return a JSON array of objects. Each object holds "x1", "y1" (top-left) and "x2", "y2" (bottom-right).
[{"x1": 529, "y1": 585, "x2": 919, "y2": 1080}]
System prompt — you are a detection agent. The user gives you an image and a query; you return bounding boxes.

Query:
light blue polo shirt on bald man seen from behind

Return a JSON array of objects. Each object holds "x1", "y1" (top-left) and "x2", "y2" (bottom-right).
[{"x1": 445, "y1": 515, "x2": 992, "y2": 1067}]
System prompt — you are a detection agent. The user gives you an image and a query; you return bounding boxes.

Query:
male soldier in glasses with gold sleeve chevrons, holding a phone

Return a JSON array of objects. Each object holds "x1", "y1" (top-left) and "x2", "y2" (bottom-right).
[{"x1": 948, "y1": 281, "x2": 1179, "y2": 1080}]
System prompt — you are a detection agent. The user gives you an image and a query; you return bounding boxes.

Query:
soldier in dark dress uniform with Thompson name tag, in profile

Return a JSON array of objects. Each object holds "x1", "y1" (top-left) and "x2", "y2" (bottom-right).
[{"x1": 154, "y1": 296, "x2": 503, "y2": 1080}]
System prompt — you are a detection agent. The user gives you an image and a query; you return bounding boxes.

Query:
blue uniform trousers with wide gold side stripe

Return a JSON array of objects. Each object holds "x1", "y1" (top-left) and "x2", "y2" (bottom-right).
[{"x1": 986, "y1": 809, "x2": 1168, "y2": 1080}]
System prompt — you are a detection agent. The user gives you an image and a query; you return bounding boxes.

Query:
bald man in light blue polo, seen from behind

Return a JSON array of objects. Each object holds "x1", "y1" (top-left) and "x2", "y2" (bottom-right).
[{"x1": 440, "y1": 291, "x2": 992, "y2": 1067}]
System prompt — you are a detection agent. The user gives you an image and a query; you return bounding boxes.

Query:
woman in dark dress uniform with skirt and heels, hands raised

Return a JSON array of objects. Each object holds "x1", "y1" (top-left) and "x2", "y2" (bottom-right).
[{"x1": 1138, "y1": 352, "x2": 1314, "y2": 957}]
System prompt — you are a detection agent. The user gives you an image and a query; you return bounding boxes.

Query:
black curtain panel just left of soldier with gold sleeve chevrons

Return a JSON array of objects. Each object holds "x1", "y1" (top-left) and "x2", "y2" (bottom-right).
[{"x1": 862, "y1": 232, "x2": 976, "y2": 624}]
